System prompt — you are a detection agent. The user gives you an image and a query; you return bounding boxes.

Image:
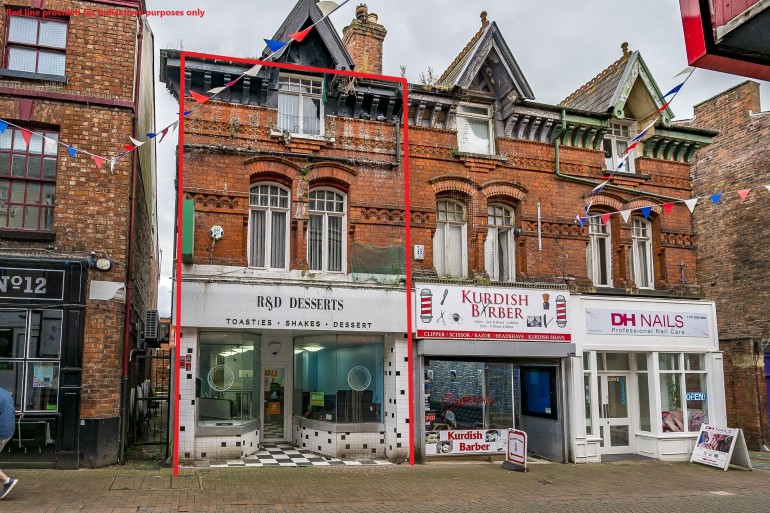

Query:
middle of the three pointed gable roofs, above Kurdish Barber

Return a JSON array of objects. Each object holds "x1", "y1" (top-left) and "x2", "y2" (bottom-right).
[{"x1": 437, "y1": 11, "x2": 535, "y2": 100}]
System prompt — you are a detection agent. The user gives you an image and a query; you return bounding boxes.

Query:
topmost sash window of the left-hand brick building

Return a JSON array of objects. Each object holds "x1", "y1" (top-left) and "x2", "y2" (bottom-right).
[{"x1": 5, "y1": 16, "x2": 67, "y2": 76}]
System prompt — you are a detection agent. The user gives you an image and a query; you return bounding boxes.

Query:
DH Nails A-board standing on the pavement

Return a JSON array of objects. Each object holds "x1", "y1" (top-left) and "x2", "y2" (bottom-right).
[{"x1": 690, "y1": 424, "x2": 751, "y2": 470}]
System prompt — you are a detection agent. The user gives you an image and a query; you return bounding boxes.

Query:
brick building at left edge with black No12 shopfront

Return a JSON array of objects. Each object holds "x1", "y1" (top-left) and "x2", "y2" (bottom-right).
[{"x1": 0, "y1": 0, "x2": 158, "y2": 468}]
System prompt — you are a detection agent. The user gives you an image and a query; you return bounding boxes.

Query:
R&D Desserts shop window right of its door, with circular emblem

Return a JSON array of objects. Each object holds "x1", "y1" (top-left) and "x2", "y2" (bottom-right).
[{"x1": 294, "y1": 335, "x2": 385, "y2": 424}]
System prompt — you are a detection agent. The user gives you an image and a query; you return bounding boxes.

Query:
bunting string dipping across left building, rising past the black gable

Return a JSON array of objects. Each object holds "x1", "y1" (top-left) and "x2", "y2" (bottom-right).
[{"x1": 0, "y1": 0, "x2": 350, "y2": 174}]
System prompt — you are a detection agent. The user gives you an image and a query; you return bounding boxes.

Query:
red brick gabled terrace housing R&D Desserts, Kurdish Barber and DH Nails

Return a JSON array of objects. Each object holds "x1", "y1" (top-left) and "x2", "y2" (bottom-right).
[{"x1": 161, "y1": 0, "x2": 725, "y2": 462}]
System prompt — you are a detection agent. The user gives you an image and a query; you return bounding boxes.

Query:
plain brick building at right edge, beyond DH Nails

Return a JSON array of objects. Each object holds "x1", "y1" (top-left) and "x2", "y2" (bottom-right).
[{"x1": 687, "y1": 81, "x2": 770, "y2": 447}]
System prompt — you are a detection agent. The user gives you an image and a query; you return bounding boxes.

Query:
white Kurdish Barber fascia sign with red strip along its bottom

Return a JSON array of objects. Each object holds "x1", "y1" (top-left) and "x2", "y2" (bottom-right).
[{"x1": 415, "y1": 284, "x2": 571, "y2": 342}]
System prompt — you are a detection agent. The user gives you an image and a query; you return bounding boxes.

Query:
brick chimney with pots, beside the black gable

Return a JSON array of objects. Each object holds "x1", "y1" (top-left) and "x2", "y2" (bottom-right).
[{"x1": 342, "y1": 4, "x2": 388, "y2": 75}]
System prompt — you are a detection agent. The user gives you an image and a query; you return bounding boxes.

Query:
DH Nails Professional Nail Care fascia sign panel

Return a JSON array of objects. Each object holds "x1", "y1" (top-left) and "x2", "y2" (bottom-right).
[{"x1": 586, "y1": 308, "x2": 710, "y2": 338}]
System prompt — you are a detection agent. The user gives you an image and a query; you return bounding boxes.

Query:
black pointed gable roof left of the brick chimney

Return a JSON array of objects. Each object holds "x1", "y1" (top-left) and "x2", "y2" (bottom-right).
[{"x1": 262, "y1": 0, "x2": 354, "y2": 70}]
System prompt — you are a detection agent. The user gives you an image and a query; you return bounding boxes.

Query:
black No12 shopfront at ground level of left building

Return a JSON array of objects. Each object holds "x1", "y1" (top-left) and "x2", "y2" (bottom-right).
[{"x1": 0, "y1": 258, "x2": 88, "y2": 469}]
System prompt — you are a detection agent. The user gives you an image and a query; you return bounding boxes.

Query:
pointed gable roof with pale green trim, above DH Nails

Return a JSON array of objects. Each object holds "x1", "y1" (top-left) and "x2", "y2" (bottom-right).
[{"x1": 559, "y1": 43, "x2": 673, "y2": 119}]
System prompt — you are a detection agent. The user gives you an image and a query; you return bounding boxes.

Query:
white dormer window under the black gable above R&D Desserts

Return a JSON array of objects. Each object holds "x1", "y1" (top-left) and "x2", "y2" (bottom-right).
[{"x1": 278, "y1": 75, "x2": 324, "y2": 135}]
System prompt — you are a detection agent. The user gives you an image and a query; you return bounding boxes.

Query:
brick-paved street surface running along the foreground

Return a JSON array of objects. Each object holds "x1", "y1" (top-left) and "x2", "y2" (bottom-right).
[{"x1": 0, "y1": 453, "x2": 770, "y2": 513}]
